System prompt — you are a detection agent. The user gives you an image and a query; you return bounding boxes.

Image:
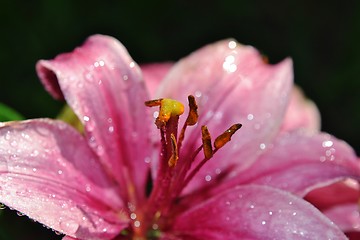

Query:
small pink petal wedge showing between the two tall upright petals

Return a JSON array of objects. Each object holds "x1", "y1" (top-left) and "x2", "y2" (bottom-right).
[{"x1": 140, "y1": 62, "x2": 174, "y2": 99}]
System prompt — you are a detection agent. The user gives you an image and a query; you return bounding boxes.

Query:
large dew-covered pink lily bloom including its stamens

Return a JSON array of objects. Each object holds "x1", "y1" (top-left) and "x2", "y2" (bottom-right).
[{"x1": 0, "y1": 35, "x2": 360, "y2": 240}]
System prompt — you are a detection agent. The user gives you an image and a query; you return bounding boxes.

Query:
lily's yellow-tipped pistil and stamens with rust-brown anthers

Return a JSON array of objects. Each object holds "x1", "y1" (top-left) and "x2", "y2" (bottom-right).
[{"x1": 128, "y1": 95, "x2": 242, "y2": 239}]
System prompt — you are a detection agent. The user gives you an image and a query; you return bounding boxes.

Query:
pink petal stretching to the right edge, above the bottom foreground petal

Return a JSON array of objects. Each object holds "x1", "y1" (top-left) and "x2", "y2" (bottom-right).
[{"x1": 224, "y1": 131, "x2": 360, "y2": 196}]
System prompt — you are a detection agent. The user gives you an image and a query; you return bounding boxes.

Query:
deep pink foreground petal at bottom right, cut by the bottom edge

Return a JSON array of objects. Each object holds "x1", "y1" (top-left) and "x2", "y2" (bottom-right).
[{"x1": 165, "y1": 185, "x2": 346, "y2": 240}]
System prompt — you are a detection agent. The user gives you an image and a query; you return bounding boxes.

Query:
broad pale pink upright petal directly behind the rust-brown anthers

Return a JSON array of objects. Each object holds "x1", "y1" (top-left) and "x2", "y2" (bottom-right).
[{"x1": 158, "y1": 40, "x2": 292, "y2": 193}]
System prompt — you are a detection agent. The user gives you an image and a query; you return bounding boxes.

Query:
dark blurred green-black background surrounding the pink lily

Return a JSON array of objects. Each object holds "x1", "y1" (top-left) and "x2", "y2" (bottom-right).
[{"x1": 0, "y1": 0, "x2": 360, "y2": 240}]
